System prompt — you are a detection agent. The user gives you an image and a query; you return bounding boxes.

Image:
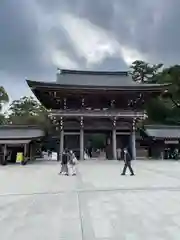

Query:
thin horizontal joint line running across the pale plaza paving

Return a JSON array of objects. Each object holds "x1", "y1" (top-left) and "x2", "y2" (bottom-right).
[{"x1": 0, "y1": 186, "x2": 180, "y2": 198}]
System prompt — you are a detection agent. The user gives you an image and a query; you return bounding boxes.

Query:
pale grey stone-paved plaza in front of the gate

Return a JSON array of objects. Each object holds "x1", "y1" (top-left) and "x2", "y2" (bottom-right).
[{"x1": 0, "y1": 160, "x2": 180, "y2": 240}]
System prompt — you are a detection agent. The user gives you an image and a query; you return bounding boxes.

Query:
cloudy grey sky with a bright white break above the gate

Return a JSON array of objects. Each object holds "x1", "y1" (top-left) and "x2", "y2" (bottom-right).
[{"x1": 0, "y1": 0, "x2": 180, "y2": 99}]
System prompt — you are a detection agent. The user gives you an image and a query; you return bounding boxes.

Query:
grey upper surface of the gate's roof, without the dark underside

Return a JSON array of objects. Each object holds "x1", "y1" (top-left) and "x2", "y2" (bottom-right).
[{"x1": 27, "y1": 69, "x2": 170, "y2": 90}]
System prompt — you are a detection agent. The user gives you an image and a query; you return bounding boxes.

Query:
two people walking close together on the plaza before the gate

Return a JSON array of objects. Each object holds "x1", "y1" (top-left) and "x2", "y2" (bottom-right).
[{"x1": 59, "y1": 149, "x2": 77, "y2": 176}]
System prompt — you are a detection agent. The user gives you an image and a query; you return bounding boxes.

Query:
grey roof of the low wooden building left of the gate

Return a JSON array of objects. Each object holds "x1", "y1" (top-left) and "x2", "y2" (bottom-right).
[{"x1": 0, "y1": 125, "x2": 44, "y2": 140}]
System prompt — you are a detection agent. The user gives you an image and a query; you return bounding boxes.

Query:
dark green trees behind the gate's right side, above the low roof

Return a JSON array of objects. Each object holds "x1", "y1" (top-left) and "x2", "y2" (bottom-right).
[{"x1": 131, "y1": 60, "x2": 180, "y2": 124}]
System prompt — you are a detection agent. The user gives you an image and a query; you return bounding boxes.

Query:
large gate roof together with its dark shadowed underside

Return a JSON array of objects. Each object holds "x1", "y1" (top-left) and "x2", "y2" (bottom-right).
[{"x1": 27, "y1": 69, "x2": 170, "y2": 109}]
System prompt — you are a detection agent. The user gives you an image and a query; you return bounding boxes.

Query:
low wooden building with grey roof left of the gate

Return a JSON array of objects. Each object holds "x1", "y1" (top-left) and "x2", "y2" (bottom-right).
[{"x1": 0, "y1": 125, "x2": 44, "y2": 164}]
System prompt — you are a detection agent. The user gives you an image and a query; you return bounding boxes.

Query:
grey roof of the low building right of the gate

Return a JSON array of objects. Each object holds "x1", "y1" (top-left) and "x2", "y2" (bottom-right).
[{"x1": 145, "y1": 125, "x2": 180, "y2": 139}]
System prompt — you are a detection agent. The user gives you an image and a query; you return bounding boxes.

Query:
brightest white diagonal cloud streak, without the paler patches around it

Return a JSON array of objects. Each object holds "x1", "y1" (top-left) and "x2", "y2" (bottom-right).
[{"x1": 60, "y1": 14, "x2": 120, "y2": 65}]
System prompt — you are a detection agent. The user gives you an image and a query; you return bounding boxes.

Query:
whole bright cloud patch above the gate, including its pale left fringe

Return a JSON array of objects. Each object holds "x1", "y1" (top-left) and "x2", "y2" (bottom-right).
[{"x1": 22, "y1": 8, "x2": 146, "y2": 69}]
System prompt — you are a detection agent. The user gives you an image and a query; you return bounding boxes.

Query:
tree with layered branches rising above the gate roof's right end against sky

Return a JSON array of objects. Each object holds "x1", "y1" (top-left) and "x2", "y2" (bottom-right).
[{"x1": 130, "y1": 60, "x2": 163, "y2": 83}]
